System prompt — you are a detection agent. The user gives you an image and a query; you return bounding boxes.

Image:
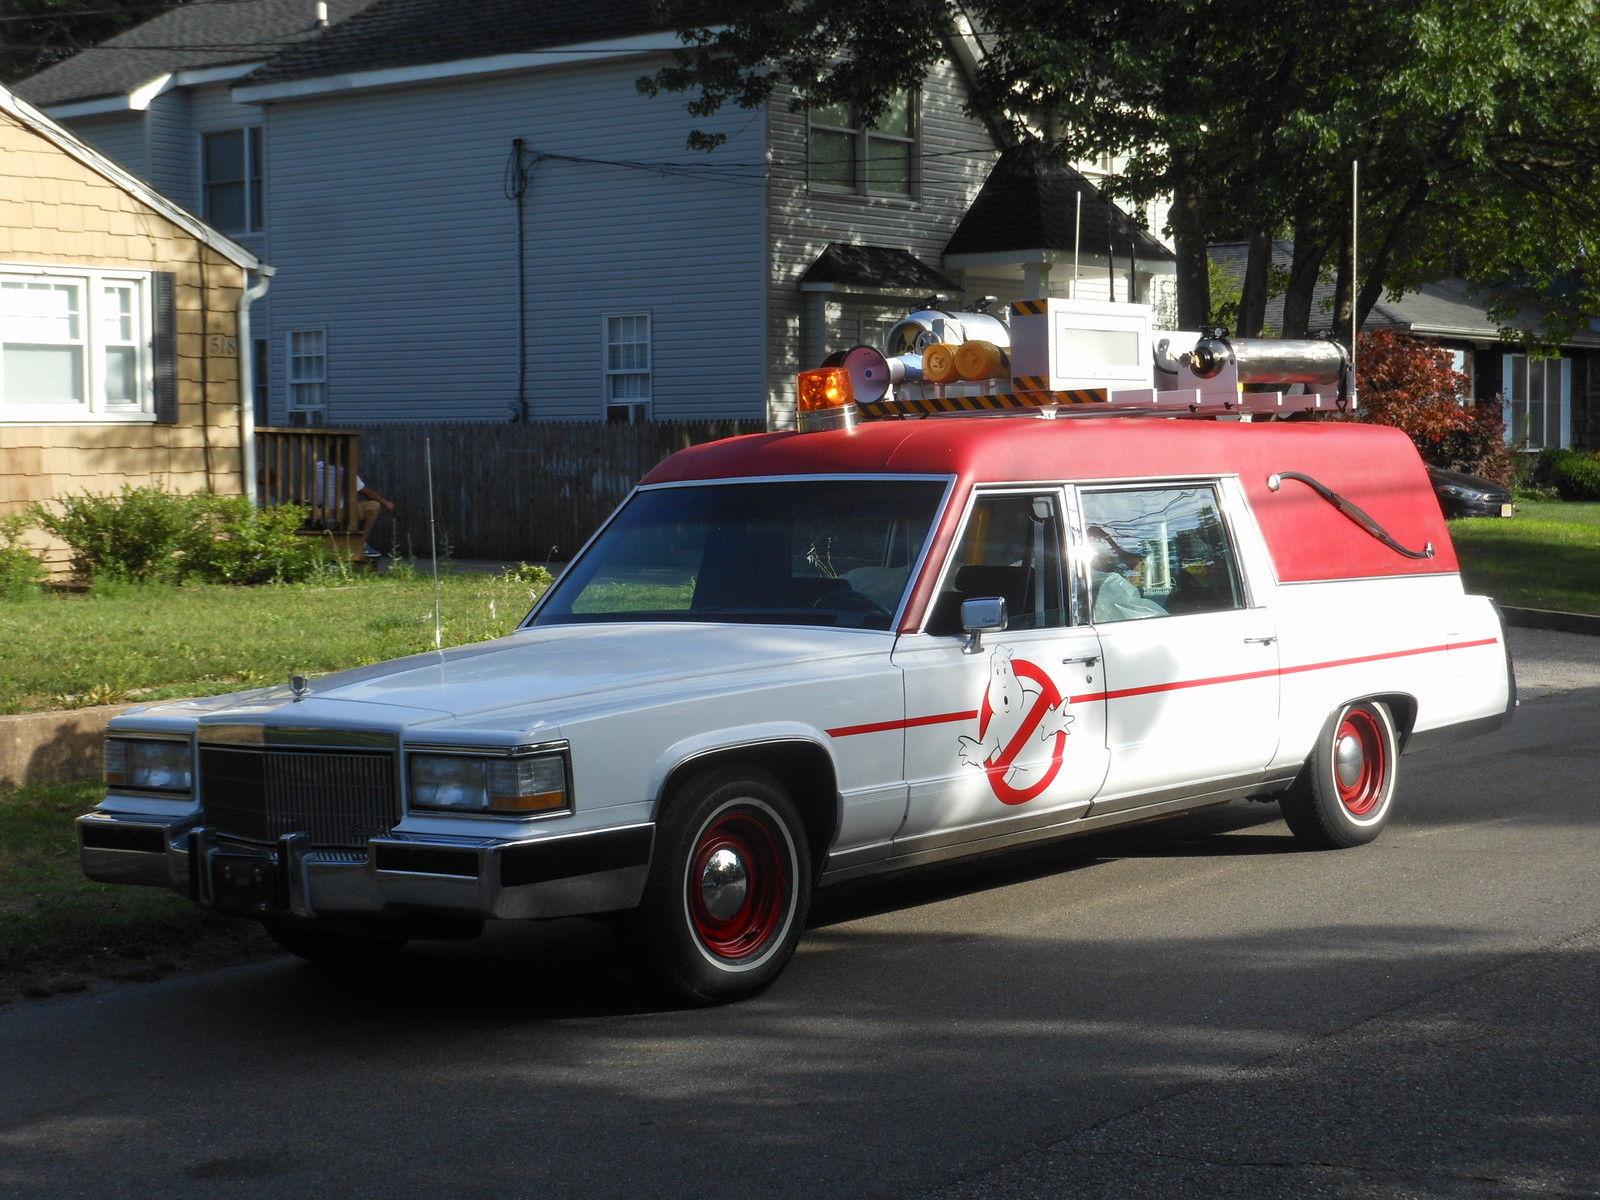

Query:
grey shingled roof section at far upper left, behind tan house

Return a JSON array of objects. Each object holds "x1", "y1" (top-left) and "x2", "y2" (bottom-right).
[{"x1": 16, "y1": 0, "x2": 379, "y2": 106}]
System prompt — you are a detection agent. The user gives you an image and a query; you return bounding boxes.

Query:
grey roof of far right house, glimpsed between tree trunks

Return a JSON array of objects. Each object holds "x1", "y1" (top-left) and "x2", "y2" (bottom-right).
[{"x1": 1211, "y1": 240, "x2": 1600, "y2": 347}]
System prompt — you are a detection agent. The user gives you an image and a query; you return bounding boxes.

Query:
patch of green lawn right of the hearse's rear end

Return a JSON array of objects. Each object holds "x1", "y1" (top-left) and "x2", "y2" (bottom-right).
[{"x1": 1450, "y1": 501, "x2": 1600, "y2": 614}]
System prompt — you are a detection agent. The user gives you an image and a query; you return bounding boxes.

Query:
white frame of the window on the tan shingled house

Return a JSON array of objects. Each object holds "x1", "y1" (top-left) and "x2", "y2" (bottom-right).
[{"x1": 0, "y1": 262, "x2": 155, "y2": 426}]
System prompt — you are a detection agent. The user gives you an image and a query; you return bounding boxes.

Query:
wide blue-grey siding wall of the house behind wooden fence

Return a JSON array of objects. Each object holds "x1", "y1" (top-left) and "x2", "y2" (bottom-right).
[{"x1": 266, "y1": 59, "x2": 766, "y2": 424}]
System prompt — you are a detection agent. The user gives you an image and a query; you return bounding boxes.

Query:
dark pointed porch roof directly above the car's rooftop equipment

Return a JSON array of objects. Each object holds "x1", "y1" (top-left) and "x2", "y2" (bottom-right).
[{"x1": 944, "y1": 144, "x2": 1173, "y2": 262}]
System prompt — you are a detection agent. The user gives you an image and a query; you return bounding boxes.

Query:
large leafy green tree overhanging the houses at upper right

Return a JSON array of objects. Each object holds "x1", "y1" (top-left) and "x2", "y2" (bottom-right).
[{"x1": 640, "y1": 0, "x2": 1600, "y2": 345}]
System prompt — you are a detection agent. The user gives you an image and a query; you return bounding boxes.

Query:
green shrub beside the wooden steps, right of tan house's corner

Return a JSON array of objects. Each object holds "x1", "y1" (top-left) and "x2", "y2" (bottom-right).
[{"x1": 178, "y1": 496, "x2": 328, "y2": 584}]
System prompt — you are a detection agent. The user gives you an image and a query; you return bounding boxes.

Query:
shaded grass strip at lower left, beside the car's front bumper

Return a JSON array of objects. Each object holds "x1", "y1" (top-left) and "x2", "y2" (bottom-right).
[{"x1": 0, "y1": 784, "x2": 269, "y2": 1003}]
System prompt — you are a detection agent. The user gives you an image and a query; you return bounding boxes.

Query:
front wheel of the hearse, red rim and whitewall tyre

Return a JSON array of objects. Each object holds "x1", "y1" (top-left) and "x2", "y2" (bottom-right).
[{"x1": 627, "y1": 770, "x2": 811, "y2": 1005}]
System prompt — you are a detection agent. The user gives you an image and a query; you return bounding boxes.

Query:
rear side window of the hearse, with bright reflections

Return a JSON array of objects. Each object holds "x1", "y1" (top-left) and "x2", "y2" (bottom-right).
[{"x1": 1080, "y1": 485, "x2": 1245, "y2": 624}]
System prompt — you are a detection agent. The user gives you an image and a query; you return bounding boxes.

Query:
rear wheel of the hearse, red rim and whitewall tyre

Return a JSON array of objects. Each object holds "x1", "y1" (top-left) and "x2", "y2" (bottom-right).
[{"x1": 1278, "y1": 701, "x2": 1400, "y2": 850}]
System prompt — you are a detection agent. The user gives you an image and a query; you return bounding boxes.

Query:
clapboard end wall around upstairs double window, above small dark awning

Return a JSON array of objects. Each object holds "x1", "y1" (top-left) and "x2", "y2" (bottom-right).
[{"x1": 768, "y1": 62, "x2": 998, "y2": 424}]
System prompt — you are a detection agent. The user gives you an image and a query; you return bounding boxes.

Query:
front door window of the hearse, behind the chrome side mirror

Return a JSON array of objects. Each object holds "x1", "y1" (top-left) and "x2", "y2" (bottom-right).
[{"x1": 928, "y1": 491, "x2": 1072, "y2": 635}]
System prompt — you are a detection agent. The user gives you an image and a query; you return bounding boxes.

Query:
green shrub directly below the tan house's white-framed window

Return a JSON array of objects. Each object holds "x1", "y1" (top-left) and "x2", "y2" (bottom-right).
[{"x1": 34, "y1": 486, "x2": 192, "y2": 582}]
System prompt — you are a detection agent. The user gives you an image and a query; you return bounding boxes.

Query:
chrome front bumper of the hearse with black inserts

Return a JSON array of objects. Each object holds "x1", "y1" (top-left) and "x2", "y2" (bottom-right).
[{"x1": 78, "y1": 811, "x2": 654, "y2": 920}]
